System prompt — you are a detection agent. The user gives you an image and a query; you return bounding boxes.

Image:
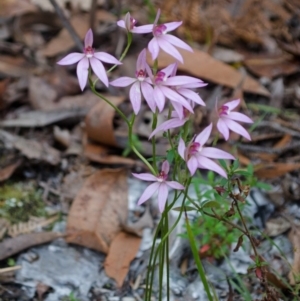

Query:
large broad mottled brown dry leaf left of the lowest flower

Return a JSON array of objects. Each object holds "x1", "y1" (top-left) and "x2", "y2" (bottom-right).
[{"x1": 67, "y1": 169, "x2": 128, "y2": 253}]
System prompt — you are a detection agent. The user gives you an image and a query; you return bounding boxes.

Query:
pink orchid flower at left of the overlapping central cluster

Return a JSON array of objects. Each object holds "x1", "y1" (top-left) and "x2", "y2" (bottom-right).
[{"x1": 110, "y1": 49, "x2": 156, "y2": 115}]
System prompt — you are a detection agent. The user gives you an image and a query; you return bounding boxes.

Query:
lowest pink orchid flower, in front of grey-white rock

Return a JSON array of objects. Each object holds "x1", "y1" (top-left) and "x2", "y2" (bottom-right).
[{"x1": 132, "y1": 161, "x2": 184, "y2": 212}]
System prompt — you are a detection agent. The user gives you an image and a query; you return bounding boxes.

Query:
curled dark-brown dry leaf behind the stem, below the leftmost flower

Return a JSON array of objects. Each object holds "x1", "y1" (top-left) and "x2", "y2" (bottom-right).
[{"x1": 85, "y1": 96, "x2": 125, "y2": 147}]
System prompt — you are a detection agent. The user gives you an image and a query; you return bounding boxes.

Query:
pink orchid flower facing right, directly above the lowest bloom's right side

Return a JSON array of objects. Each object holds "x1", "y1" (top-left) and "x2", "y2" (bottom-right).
[{"x1": 178, "y1": 123, "x2": 235, "y2": 178}]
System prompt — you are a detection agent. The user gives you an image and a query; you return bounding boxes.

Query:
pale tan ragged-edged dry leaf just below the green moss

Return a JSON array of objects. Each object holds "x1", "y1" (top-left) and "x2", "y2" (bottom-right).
[{"x1": 8, "y1": 215, "x2": 58, "y2": 237}]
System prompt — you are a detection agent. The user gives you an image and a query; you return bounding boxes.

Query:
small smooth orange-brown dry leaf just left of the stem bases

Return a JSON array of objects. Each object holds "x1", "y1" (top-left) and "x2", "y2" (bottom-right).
[{"x1": 104, "y1": 232, "x2": 141, "y2": 287}]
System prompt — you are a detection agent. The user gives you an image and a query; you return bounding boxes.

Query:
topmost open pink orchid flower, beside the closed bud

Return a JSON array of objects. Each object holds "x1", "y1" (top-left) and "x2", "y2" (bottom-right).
[{"x1": 148, "y1": 9, "x2": 193, "y2": 63}]
